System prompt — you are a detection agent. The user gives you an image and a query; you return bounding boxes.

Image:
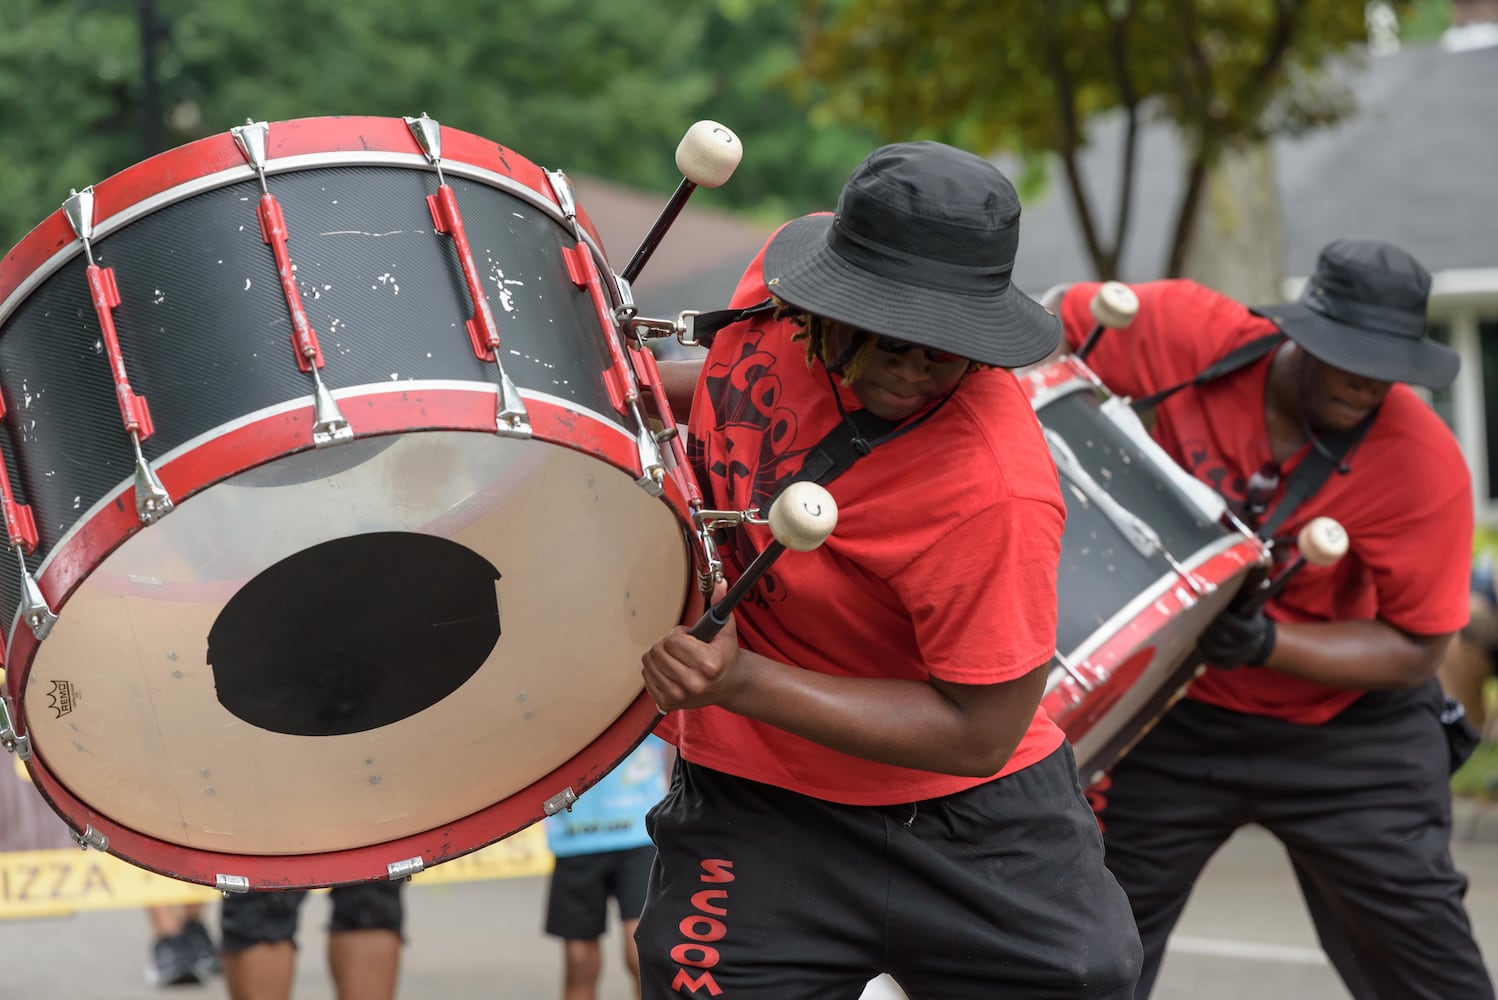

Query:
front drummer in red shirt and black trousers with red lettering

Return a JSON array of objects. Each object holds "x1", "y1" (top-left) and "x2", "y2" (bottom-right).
[{"x1": 635, "y1": 142, "x2": 1138, "y2": 1000}]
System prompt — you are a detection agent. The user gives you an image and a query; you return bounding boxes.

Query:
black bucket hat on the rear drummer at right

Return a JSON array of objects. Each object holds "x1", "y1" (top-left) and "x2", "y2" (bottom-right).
[{"x1": 1252, "y1": 240, "x2": 1462, "y2": 389}]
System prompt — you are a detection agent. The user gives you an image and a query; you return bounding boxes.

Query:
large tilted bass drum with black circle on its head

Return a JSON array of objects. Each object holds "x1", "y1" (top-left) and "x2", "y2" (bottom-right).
[{"x1": 0, "y1": 118, "x2": 709, "y2": 891}]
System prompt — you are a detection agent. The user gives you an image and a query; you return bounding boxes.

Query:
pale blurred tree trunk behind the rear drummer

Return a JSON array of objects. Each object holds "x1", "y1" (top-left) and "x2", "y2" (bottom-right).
[{"x1": 1182, "y1": 144, "x2": 1285, "y2": 305}]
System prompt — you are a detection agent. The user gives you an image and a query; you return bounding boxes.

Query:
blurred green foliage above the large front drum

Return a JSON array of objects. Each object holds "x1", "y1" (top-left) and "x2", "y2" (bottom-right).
[{"x1": 0, "y1": 0, "x2": 873, "y2": 253}]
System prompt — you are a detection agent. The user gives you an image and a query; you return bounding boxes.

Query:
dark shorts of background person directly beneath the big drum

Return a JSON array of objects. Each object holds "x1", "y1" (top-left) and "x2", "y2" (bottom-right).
[{"x1": 219, "y1": 882, "x2": 404, "y2": 955}]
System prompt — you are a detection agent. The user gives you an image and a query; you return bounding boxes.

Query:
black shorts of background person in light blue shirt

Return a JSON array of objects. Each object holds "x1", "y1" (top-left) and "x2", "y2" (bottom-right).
[{"x1": 545, "y1": 844, "x2": 655, "y2": 942}]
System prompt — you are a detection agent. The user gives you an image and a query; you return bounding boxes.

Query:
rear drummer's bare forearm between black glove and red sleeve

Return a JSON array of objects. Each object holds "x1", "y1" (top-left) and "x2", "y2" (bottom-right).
[{"x1": 1264, "y1": 621, "x2": 1452, "y2": 690}]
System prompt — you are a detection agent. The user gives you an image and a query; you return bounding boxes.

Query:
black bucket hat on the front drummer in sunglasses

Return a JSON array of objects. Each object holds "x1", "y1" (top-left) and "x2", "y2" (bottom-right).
[{"x1": 764, "y1": 142, "x2": 1061, "y2": 368}]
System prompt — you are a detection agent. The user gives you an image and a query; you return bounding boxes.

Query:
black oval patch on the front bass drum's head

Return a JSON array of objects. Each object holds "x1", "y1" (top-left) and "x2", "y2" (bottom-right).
[{"x1": 208, "y1": 531, "x2": 500, "y2": 737}]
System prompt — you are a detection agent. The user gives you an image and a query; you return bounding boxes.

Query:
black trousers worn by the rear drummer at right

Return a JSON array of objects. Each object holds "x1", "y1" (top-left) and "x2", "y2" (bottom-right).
[{"x1": 1101, "y1": 679, "x2": 1494, "y2": 1000}]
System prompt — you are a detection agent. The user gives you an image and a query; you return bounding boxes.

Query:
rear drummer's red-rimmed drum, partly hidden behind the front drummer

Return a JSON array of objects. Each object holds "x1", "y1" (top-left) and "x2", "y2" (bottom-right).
[{"x1": 1020, "y1": 356, "x2": 1269, "y2": 783}]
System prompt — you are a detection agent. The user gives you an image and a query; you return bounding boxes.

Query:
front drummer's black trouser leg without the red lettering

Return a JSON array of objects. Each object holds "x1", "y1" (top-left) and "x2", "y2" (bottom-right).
[{"x1": 881, "y1": 744, "x2": 1140, "y2": 1000}]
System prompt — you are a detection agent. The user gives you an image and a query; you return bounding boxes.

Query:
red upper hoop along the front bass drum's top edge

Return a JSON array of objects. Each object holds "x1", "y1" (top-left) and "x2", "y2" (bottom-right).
[{"x1": 0, "y1": 115, "x2": 602, "y2": 322}]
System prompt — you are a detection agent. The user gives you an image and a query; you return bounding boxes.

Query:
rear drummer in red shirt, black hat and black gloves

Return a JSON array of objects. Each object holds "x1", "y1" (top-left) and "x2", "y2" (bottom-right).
[{"x1": 1061, "y1": 240, "x2": 1494, "y2": 1000}]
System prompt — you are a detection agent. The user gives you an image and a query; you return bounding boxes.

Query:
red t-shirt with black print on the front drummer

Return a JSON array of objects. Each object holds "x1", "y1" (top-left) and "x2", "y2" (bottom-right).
[{"x1": 658, "y1": 236, "x2": 1065, "y2": 805}]
